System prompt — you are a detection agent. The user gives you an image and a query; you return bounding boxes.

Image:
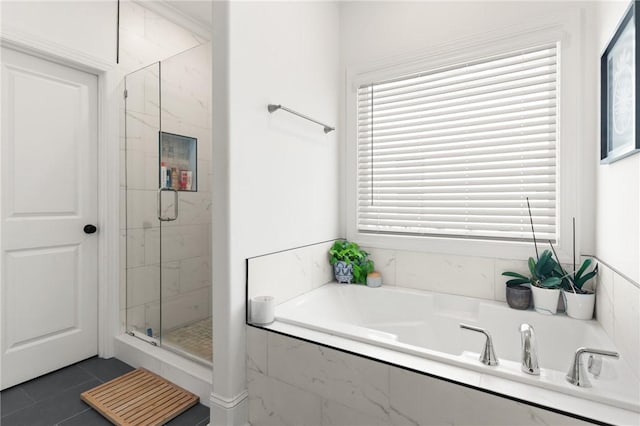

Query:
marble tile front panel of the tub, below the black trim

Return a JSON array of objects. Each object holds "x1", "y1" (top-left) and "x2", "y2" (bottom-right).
[{"x1": 247, "y1": 327, "x2": 586, "y2": 426}]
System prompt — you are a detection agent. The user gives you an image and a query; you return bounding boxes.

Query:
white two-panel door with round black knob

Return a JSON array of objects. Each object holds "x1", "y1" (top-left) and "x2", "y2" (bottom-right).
[{"x1": 0, "y1": 48, "x2": 99, "y2": 389}]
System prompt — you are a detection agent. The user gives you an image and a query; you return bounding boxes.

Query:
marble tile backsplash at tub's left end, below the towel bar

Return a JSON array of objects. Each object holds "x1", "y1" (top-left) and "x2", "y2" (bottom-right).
[{"x1": 247, "y1": 240, "x2": 333, "y2": 305}]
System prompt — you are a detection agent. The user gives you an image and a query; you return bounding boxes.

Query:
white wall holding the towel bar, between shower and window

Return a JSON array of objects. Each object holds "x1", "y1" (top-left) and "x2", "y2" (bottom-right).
[{"x1": 212, "y1": 2, "x2": 339, "y2": 424}]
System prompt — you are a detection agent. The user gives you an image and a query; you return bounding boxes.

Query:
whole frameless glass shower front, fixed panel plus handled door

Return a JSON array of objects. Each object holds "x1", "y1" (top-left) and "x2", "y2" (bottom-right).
[{"x1": 122, "y1": 45, "x2": 212, "y2": 363}]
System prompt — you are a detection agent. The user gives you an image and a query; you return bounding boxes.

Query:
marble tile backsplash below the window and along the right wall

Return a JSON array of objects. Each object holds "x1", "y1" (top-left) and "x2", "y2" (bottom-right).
[{"x1": 365, "y1": 247, "x2": 640, "y2": 377}]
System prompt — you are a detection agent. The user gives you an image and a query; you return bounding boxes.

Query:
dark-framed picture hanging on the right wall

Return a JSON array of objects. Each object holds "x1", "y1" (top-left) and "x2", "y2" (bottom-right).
[{"x1": 600, "y1": 0, "x2": 640, "y2": 164}]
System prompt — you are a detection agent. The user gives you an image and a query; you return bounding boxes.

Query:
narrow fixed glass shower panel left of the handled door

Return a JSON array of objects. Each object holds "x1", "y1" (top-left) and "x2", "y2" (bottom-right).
[{"x1": 122, "y1": 63, "x2": 161, "y2": 344}]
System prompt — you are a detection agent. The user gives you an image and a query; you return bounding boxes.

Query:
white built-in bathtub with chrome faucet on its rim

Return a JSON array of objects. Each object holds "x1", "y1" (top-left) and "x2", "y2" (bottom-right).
[{"x1": 276, "y1": 284, "x2": 640, "y2": 412}]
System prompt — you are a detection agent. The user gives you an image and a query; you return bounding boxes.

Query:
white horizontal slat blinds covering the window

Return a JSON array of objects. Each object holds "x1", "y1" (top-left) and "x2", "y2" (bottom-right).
[{"x1": 357, "y1": 44, "x2": 558, "y2": 241}]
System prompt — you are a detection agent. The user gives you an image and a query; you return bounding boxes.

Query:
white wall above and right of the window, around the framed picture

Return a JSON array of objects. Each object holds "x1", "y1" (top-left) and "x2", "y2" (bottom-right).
[{"x1": 340, "y1": 1, "x2": 640, "y2": 282}]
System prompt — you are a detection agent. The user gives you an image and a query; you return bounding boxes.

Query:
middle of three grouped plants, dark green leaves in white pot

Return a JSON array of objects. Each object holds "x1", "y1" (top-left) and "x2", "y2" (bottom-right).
[{"x1": 502, "y1": 250, "x2": 562, "y2": 314}]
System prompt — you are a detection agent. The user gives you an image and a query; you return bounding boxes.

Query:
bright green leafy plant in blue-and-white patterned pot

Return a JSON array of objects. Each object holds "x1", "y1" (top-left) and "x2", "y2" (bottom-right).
[{"x1": 329, "y1": 240, "x2": 373, "y2": 284}]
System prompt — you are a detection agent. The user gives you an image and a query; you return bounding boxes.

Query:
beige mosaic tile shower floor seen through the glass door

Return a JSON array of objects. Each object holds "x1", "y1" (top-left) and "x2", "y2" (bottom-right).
[{"x1": 162, "y1": 318, "x2": 213, "y2": 362}]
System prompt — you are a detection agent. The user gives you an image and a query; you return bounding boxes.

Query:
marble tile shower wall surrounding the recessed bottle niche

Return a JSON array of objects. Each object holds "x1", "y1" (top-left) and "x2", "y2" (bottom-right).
[{"x1": 120, "y1": 1, "x2": 211, "y2": 332}]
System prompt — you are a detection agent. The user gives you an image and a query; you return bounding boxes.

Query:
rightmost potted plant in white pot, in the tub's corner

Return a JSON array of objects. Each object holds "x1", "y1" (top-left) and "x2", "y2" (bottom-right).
[{"x1": 561, "y1": 259, "x2": 598, "y2": 320}]
